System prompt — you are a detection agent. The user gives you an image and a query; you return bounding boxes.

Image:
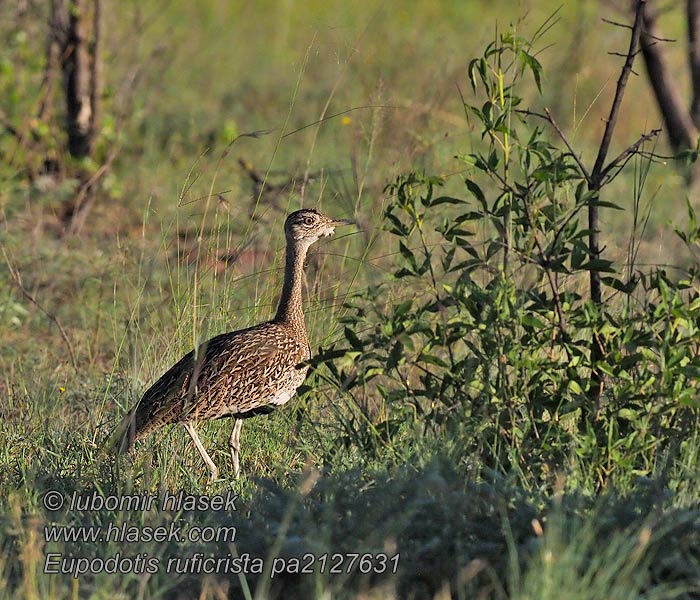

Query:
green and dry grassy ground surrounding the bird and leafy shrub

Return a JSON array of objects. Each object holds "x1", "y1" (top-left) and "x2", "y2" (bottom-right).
[{"x1": 0, "y1": 0, "x2": 700, "y2": 600}]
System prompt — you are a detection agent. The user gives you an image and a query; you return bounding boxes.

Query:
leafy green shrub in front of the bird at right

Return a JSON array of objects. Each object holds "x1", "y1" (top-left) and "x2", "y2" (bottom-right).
[{"x1": 320, "y1": 25, "x2": 700, "y2": 489}]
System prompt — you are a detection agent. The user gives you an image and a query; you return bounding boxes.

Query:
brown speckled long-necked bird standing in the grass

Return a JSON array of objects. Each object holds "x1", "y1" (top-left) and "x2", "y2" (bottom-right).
[{"x1": 111, "y1": 208, "x2": 354, "y2": 481}]
